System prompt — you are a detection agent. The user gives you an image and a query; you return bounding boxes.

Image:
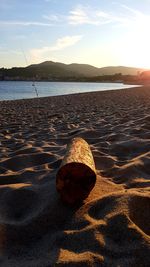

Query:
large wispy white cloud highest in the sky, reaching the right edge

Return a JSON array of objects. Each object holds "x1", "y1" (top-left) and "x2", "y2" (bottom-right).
[{"x1": 43, "y1": 4, "x2": 149, "y2": 27}]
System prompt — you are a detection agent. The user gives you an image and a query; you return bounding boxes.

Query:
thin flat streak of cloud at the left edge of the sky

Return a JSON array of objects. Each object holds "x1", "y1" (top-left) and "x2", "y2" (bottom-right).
[{"x1": 0, "y1": 20, "x2": 52, "y2": 26}]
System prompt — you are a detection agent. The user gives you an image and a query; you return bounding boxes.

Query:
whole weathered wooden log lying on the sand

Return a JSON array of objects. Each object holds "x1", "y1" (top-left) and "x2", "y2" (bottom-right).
[{"x1": 56, "y1": 138, "x2": 96, "y2": 204}]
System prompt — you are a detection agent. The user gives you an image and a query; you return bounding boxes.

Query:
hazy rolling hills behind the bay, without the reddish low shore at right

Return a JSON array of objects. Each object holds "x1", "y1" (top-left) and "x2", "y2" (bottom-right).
[{"x1": 0, "y1": 61, "x2": 146, "y2": 80}]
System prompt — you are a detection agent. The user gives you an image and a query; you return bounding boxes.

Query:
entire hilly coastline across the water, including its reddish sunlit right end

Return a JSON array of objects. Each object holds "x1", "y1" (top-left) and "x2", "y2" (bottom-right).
[{"x1": 0, "y1": 61, "x2": 150, "y2": 84}]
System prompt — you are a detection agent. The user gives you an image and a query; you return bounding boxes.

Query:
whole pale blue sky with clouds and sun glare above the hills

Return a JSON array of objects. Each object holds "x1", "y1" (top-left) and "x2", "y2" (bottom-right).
[{"x1": 0, "y1": 0, "x2": 150, "y2": 69}]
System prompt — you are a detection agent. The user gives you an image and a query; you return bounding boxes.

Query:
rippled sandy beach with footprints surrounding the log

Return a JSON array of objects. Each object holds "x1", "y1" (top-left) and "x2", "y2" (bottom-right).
[{"x1": 0, "y1": 86, "x2": 150, "y2": 267}]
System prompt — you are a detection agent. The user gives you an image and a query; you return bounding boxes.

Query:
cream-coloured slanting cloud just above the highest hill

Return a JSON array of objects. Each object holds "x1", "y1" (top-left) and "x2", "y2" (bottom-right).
[{"x1": 30, "y1": 35, "x2": 82, "y2": 62}]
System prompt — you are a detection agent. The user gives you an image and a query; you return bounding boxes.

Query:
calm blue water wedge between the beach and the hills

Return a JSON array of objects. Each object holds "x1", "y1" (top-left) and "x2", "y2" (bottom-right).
[{"x1": 0, "y1": 81, "x2": 137, "y2": 100}]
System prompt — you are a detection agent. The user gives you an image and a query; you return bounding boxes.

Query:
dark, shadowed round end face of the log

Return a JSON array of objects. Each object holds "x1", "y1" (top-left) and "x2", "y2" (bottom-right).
[{"x1": 56, "y1": 162, "x2": 96, "y2": 205}]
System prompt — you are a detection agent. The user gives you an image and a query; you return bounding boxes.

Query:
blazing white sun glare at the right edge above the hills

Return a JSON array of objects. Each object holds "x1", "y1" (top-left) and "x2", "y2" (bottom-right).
[{"x1": 112, "y1": 15, "x2": 150, "y2": 69}]
